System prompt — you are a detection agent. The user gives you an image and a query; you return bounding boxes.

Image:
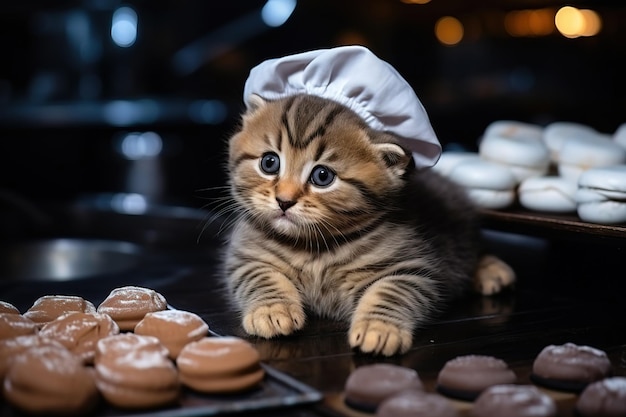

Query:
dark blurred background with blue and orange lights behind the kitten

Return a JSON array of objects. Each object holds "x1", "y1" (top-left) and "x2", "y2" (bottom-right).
[{"x1": 0, "y1": 0, "x2": 626, "y2": 207}]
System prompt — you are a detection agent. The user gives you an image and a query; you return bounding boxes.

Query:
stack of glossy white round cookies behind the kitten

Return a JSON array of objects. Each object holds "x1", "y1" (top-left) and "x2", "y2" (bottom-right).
[{"x1": 433, "y1": 120, "x2": 626, "y2": 224}]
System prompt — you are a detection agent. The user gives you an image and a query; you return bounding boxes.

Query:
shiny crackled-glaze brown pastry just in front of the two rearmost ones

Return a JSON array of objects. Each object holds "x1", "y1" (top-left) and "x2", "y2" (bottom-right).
[{"x1": 39, "y1": 311, "x2": 120, "y2": 364}]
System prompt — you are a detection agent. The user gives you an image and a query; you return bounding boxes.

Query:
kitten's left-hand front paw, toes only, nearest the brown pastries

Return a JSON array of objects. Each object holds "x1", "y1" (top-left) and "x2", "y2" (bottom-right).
[{"x1": 243, "y1": 303, "x2": 306, "y2": 339}]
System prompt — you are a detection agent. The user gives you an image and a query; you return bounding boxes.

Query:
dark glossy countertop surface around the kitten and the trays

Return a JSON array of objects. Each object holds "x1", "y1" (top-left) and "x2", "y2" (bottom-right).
[{"x1": 0, "y1": 200, "x2": 626, "y2": 416}]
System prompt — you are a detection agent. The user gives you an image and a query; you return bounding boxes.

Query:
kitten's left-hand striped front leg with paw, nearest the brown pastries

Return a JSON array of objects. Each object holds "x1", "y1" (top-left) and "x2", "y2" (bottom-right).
[{"x1": 236, "y1": 271, "x2": 306, "y2": 339}]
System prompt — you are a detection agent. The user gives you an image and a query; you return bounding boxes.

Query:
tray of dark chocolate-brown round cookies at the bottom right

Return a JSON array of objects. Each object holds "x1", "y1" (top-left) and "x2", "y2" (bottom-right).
[{"x1": 323, "y1": 343, "x2": 626, "y2": 417}]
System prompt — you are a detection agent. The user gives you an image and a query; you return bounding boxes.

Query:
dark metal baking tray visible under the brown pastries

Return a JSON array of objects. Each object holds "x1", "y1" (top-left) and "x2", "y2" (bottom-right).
[{"x1": 0, "y1": 364, "x2": 323, "y2": 417}]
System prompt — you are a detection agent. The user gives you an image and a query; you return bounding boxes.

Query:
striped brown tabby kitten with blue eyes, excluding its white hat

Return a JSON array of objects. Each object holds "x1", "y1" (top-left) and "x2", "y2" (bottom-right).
[{"x1": 223, "y1": 95, "x2": 515, "y2": 356}]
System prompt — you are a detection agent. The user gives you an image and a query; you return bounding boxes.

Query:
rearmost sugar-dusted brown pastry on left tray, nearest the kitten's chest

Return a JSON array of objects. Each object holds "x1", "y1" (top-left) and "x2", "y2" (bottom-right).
[{"x1": 98, "y1": 285, "x2": 167, "y2": 331}]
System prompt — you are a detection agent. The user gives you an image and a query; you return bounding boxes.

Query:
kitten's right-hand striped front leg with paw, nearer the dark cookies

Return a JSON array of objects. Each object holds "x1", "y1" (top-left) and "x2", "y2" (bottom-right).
[{"x1": 348, "y1": 276, "x2": 435, "y2": 356}]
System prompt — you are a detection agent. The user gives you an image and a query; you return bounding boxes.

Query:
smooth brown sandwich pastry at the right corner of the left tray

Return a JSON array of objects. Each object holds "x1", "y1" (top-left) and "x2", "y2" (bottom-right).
[{"x1": 176, "y1": 337, "x2": 265, "y2": 393}]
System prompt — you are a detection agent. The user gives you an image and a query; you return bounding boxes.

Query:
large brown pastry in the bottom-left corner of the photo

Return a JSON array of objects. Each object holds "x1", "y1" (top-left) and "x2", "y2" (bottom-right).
[{"x1": 4, "y1": 344, "x2": 99, "y2": 416}]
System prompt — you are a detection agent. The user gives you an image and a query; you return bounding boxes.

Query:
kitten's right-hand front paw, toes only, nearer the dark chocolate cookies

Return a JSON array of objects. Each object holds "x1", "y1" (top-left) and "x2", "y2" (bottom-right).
[{"x1": 348, "y1": 320, "x2": 413, "y2": 356}]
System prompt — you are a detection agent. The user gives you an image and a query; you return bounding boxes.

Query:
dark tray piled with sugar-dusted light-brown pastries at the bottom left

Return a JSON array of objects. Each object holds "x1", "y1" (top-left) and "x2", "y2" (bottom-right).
[{"x1": 0, "y1": 286, "x2": 323, "y2": 417}]
